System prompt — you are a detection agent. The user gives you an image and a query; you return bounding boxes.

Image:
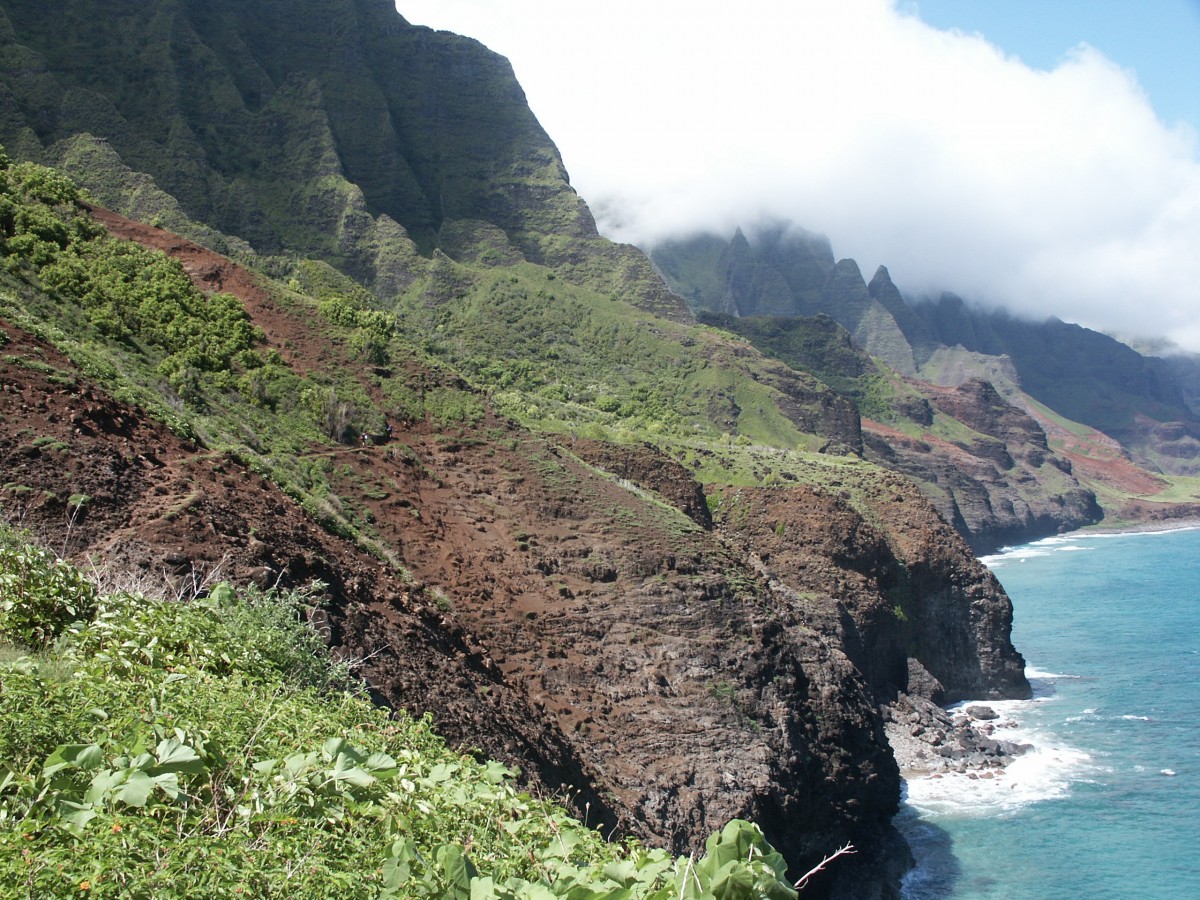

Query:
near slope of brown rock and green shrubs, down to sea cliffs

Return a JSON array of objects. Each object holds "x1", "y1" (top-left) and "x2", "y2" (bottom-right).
[{"x1": 0, "y1": 150, "x2": 1028, "y2": 896}]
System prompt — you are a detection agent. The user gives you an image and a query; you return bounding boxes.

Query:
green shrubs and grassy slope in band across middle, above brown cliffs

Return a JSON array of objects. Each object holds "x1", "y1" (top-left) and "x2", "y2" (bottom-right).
[{"x1": 0, "y1": 148, "x2": 844, "y2": 540}]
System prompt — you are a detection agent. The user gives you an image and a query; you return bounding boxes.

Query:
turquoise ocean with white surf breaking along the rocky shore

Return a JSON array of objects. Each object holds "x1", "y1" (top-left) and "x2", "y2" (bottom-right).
[{"x1": 896, "y1": 529, "x2": 1200, "y2": 900}]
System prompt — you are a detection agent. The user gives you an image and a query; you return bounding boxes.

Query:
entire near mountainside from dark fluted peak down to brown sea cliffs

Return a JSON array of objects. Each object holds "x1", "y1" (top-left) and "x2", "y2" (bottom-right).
[{"x1": 0, "y1": 0, "x2": 1033, "y2": 896}]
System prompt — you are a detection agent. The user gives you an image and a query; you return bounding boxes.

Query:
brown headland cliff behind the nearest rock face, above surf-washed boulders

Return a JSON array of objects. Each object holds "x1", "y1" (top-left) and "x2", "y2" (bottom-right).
[{"x1": 718, "y1": 470, "x2": 1030, "y2": 702}]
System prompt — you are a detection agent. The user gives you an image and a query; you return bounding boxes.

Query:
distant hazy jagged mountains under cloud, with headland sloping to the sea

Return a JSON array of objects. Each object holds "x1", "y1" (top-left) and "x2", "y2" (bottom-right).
[{"x1": 652, "y1": 222, "x2": 1200, "y2": 552}]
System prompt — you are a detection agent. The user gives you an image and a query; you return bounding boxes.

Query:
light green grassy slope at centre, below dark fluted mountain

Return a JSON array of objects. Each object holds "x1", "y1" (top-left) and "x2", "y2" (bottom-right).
[{"x1": 396, "y1": 264, "x2": 824, "y2": 448}]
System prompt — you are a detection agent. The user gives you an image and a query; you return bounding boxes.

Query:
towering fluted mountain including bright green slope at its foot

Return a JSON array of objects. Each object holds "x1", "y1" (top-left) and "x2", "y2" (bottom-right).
[{"x1": 0, "y1": 0, "x2": 883, "y2": 452}]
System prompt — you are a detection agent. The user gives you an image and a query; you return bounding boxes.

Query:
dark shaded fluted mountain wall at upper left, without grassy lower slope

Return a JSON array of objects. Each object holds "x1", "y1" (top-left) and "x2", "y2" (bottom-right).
[{"x1": 0, "y1": 0, "x2": 686, "y2": 317}]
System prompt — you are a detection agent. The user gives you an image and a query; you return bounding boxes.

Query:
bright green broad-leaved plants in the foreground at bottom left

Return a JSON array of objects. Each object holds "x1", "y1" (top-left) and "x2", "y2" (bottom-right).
[{"x1": 0, "y1": 527, "x2": 796, "y2": 900}]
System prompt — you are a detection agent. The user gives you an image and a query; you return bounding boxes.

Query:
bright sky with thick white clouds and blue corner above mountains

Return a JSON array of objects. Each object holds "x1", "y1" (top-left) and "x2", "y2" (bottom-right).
[{"x1": 397, "y1": 0, "x2": 1200, "y2": 352}]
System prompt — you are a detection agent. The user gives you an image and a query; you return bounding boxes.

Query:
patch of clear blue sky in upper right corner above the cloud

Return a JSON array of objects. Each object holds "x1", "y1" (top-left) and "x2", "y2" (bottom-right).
[{"x1": 900, "y1": 0, "x2": 1200, "y2": 131}]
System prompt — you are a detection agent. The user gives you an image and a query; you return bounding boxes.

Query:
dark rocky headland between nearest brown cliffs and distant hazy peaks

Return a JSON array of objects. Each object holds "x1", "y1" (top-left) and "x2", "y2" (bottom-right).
[{"x1": 700, "y1": 314, "x2": 1104, "y2": 553}]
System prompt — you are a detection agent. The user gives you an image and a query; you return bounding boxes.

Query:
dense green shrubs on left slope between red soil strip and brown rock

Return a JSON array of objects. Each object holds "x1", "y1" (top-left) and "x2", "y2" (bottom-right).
[{"x1": 0, "y1": 152, "x2": 456, "y2": 550}]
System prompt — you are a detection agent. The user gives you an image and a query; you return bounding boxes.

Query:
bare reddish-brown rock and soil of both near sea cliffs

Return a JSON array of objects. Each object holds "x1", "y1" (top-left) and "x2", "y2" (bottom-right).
[{"x1": 0, "y1": 196, "x2": 1025, "y2": 896}]
